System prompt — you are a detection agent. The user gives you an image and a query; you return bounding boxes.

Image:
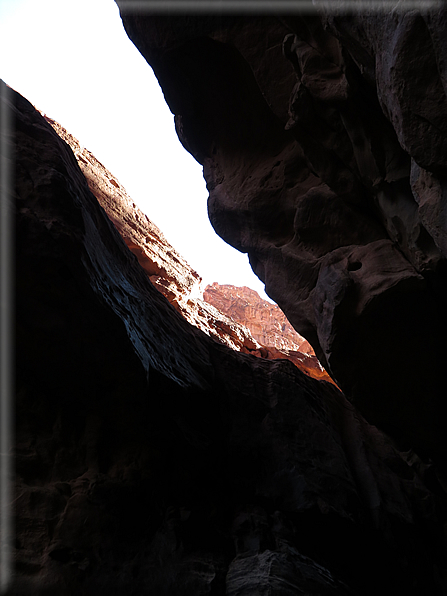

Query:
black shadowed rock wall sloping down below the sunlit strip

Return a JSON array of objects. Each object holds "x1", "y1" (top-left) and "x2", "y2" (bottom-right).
[{"x1": 4, "y1": 84, "x2": 447, "y2": 596}]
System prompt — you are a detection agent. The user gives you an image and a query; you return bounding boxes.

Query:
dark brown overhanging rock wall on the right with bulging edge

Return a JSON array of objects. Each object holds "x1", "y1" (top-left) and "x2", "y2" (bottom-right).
[{"x1": 117, "y1": 0, "x2": 447, "y2": 466}]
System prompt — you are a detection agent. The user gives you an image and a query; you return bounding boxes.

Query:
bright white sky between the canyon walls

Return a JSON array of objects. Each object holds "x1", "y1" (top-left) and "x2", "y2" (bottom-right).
[{"x1": 0, "y1": 0, "x2": 274, "y2": 299}]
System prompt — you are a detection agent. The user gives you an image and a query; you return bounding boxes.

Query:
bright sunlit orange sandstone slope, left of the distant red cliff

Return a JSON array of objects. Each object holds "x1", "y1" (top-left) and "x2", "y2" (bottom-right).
[{"x1": 45, "y1": 115, "x2": 261, "y2": 353}]
